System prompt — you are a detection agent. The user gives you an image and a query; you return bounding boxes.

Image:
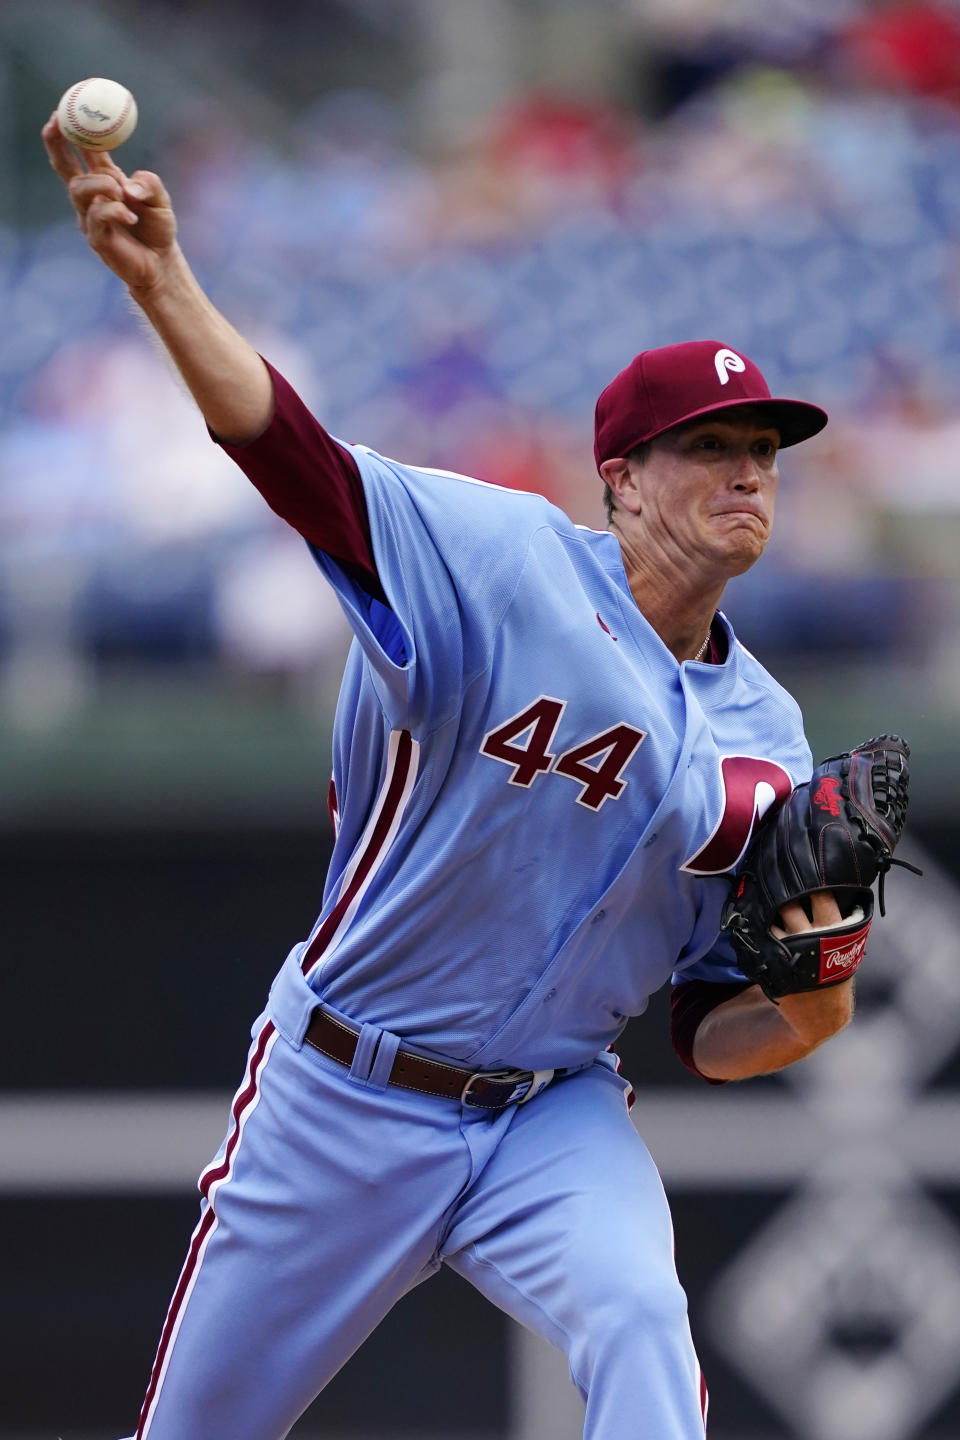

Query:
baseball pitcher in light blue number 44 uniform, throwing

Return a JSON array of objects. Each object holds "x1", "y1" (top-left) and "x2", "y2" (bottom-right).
[{"x1": 43, "y1": 118, "x2": 903, "y2": 1440}]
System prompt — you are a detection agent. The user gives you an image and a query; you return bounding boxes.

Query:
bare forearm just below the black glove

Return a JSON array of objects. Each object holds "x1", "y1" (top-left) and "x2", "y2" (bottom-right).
[{"x1": 694, "y1": 981, "x2": 853, "y2": 1080}]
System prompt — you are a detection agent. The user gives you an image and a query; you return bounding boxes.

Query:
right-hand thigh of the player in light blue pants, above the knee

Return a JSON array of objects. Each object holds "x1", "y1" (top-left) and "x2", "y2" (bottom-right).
[{"x1": 443, "y1": 1061, "x2": 687, "y2": 1358}]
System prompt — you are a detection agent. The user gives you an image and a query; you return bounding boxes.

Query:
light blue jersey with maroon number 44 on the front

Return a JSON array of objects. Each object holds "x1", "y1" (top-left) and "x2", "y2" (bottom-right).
[{"x1": 304, "y1": 448, "x2": 810, "y2": 1068}]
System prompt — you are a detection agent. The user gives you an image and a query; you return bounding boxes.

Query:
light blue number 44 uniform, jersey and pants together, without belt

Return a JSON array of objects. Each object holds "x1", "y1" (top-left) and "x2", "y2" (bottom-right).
[{"x1": 137, "y1": 449, "x2": 810, "y2": 1440}]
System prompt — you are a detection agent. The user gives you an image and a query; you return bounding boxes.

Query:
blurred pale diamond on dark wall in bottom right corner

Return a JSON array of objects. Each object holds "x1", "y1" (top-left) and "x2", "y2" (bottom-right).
[{"x1": 710, "y1": 1184, "x2": 960, "y2": 1440}]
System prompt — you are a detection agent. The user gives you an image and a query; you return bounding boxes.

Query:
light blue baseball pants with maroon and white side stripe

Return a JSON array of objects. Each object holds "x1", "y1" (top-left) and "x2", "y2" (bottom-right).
[{"x1": 127, "y1": 965, "x2": 705, "y2": 1440}]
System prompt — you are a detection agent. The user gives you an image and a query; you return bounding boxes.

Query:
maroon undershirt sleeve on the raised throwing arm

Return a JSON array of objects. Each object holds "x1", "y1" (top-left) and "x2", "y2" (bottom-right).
[{"x1": 213, "y1": 361, "x2": 387, "y2": 605}]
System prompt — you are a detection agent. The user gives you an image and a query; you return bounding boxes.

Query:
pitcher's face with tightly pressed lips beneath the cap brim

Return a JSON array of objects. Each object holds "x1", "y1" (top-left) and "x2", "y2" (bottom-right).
[{"x1": 629, "y1": 413, "x2": 780, "y2": 576}]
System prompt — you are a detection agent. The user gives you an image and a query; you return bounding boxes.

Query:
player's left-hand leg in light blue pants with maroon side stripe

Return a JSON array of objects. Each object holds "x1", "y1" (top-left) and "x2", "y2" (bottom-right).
[{"x1": 136, "y1": 1027, "x2": 471, "y2": 1440}]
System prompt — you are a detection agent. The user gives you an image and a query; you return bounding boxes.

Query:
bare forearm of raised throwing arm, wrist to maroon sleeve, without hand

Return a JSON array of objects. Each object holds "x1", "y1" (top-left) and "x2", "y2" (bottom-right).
[{"x1": 130, "y1": 248, "x2": 273, "y2": 445}]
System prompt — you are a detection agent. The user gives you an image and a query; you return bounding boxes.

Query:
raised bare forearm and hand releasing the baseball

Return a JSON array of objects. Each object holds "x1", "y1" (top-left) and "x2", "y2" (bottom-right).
[{"x1": 43, "y1": 114, "x2": 273, "y2": 445}]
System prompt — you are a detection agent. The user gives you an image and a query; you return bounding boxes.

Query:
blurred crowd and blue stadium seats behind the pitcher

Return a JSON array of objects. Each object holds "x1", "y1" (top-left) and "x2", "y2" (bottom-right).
[{"x1": 0, "y1": 3, "x2": 960, "y2": 714}]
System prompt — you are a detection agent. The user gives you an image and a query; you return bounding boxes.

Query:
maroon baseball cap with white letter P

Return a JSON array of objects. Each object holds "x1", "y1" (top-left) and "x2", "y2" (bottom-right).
[{"x1": 593, "y1": 340, "x2": 826, "y2": 469}]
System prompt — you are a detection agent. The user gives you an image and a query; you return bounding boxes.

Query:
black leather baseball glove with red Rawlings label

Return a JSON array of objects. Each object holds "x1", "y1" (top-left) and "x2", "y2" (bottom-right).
[{"x1": 721, "y1": 734, "x2": 920, "y2": 1002}]
